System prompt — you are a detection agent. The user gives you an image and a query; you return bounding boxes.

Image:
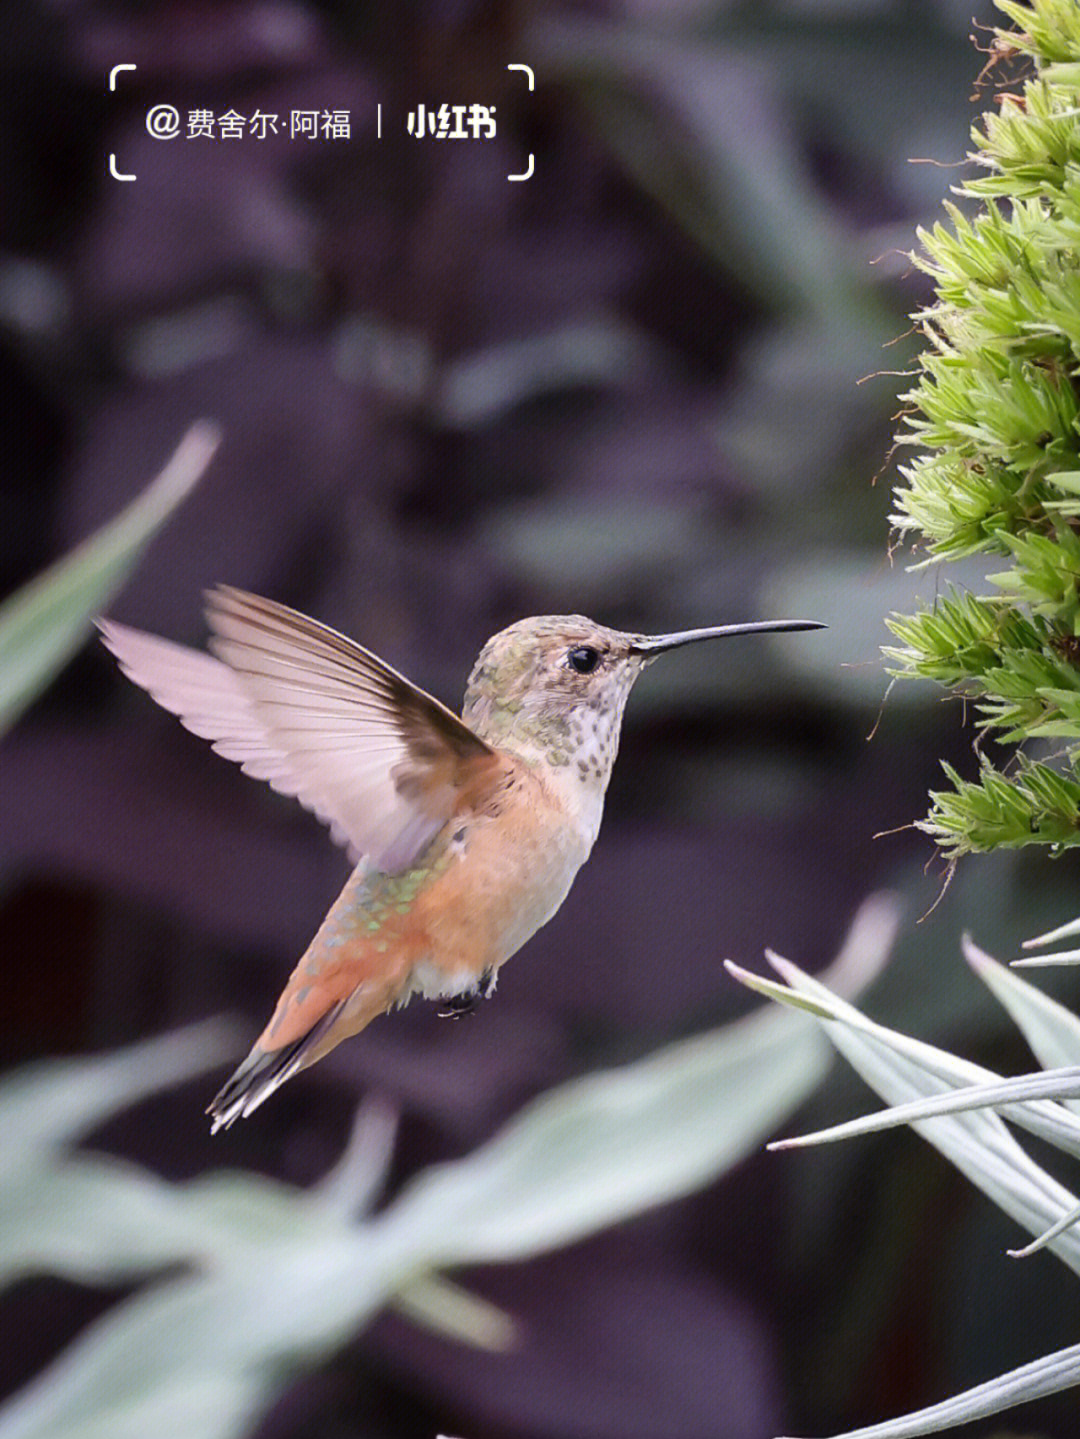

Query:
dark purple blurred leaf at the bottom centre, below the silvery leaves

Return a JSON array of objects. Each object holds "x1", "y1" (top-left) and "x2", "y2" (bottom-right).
[{"x1": 376, "y1": 1226, "x2": 782, "y2": 1439}]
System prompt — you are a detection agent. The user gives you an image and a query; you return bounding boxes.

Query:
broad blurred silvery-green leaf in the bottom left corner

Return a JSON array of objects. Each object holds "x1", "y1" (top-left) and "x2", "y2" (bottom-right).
[{"x1": 0, "y1": 1225, "x2": 422, "y2": 1439}]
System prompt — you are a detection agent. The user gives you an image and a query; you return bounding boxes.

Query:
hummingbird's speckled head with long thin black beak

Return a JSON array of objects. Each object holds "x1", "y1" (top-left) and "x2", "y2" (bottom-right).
[{"x1": 462, "y1": 614, "x2": 821, "y2": 793}]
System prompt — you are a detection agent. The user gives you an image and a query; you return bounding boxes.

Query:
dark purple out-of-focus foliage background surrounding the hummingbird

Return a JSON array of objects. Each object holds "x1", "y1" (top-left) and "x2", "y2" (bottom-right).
[{"x1": 8, "y1": 0, "x2": 1077, "y2": 1439}]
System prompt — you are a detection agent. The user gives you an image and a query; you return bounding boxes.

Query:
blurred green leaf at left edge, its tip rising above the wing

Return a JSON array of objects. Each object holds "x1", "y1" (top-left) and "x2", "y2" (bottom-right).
[{"x1": 0, "y1": 420, "x2": 219, "y2": 732}]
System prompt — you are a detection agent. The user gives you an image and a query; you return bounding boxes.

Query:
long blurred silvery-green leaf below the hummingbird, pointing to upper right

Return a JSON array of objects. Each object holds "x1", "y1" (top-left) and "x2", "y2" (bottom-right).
[{"x1": 384, "y1": 898, "x2": 896, "y2": 1265}]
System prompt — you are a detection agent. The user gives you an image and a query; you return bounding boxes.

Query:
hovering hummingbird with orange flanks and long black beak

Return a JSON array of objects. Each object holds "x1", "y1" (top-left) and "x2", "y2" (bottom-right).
[{"x1": 98, "y1": 586, "x2": 824, "y2": 1132}]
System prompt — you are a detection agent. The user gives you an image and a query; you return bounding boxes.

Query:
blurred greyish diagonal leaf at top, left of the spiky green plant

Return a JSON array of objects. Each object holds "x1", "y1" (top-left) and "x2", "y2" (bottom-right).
[{"x1": 529, "y1": 17, "x2": 856, "y2": 315}]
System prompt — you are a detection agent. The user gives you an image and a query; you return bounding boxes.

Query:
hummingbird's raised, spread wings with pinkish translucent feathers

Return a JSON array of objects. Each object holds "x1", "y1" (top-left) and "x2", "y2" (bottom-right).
[{"x1": 99, "y1": 586, "x2": 499, "y2": 873}]
